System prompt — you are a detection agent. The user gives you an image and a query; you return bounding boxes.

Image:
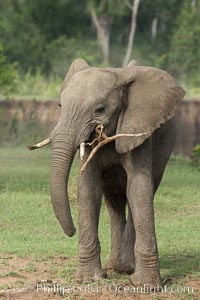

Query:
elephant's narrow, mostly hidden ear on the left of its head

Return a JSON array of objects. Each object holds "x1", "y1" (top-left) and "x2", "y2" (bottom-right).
[{"x1": 60, "y1": 58, "x2": 90, "y2": 94}]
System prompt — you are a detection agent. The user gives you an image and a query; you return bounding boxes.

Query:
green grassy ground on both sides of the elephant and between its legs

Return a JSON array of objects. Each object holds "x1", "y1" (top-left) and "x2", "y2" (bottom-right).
[{"x1": 0, "y1": 148, "x2": 200, "y2": 299}]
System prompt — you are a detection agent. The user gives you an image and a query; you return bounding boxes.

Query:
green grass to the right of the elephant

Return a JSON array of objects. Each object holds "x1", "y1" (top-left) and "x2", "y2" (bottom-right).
[{"x1": 155, "y1": 158, "x2": 200, "y2": 276}]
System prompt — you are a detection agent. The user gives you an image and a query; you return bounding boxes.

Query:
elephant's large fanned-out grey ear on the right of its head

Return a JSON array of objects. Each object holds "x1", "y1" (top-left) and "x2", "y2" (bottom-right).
[{"x1": 115, "y1": 63, "x2": 185, "y2": 153}]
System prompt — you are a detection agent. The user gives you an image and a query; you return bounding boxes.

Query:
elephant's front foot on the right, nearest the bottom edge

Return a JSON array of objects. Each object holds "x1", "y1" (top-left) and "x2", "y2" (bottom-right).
[{"x1": 130, "y1": 272, "x2": 162, "y2": 292}]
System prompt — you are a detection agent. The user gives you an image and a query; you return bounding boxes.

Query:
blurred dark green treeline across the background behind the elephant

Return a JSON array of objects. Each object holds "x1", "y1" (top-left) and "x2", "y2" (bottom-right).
[{"x1": 0, "y1": 0, "x2": 200, "y2": 95}]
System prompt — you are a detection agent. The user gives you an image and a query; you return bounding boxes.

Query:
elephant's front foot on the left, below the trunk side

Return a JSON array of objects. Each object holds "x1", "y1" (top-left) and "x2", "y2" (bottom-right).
[{"x1": 76, "y1": 268, "x2": 107, "y2": 283}]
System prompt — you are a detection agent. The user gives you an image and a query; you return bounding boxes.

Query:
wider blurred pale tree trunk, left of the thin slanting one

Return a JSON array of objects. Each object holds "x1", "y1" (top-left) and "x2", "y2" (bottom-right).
[{"x1": 90, "y1": 8, "x2": 110, "y2": 64}]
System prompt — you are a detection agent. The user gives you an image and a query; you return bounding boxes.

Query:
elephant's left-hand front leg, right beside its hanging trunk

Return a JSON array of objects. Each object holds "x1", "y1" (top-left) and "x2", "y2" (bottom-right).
[{"x1": 76, "y1": 162, "x2": 106, "y2": 281}]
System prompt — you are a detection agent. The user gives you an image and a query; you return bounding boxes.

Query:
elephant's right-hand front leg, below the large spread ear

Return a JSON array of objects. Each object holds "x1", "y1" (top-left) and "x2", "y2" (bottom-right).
[{"x1": 126, "y1": 141, "x2": 161, "y2": 288}]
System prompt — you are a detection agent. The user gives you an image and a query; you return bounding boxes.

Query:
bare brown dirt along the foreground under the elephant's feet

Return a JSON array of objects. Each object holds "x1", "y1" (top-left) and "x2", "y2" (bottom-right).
[{"x1": 0, "y1": 256, "x2": 200, "y2": 300}]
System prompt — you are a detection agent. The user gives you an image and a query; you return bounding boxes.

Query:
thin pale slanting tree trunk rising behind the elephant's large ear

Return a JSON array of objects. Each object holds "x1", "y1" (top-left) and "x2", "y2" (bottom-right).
[{"x1": 123, "y1": 0, "x2": 140, "y2": 67}]
